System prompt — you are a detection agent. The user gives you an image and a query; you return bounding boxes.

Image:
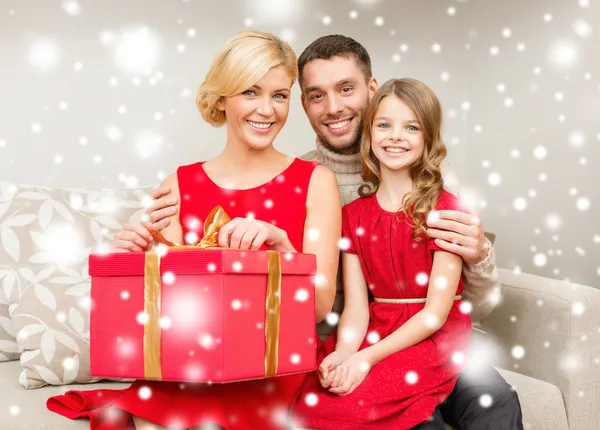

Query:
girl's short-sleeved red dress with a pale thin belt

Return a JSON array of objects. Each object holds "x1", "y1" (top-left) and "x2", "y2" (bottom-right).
[{"x1": 291, "y1": 191, "x2": 471, "y2": 430}]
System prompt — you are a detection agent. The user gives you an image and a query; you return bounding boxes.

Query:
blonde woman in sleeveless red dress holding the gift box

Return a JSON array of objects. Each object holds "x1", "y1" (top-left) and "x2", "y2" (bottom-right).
[{"x1": 48, "y1": 32, "x2": 341, "y2": 430}]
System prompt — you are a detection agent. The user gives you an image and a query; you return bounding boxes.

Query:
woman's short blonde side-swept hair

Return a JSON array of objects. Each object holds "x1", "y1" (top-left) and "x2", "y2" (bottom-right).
[{"x1": 196, "y1": 31, "x2": 298, "y2": 127}]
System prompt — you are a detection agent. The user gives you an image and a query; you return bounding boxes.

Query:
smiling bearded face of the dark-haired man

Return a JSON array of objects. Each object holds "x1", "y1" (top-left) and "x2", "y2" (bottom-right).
[{"x1": 302, "y1": 57, "x2": 377, "y2": 153}]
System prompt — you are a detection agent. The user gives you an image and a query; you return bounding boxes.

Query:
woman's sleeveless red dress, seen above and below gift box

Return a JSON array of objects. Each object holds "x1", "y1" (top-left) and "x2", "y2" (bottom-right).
[{"x1": 47, "y1": 159, "x2": 322, "y2": 430}]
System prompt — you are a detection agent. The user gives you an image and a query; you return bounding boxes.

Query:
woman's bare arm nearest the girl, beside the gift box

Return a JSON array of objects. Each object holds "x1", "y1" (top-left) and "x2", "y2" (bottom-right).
[{"x1": 302, "y1": 166, "x2": 342, "y2": 323}]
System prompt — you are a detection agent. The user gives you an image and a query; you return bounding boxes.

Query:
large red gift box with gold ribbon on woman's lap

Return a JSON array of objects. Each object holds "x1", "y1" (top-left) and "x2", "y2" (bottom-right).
[{"x1": 89, "y1": 247, "x2": 316, "y2": 382}]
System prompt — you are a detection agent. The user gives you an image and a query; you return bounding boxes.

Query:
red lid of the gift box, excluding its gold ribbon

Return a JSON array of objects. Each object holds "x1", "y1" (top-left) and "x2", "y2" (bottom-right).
[{"x1": 89, "y1": 249, "x2": 316, "y2": 277}]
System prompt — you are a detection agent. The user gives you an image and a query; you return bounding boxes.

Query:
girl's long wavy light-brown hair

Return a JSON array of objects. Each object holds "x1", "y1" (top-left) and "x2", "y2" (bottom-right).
[{"x1": 359, "y1": 78, "x2": 446, "y2": 241}]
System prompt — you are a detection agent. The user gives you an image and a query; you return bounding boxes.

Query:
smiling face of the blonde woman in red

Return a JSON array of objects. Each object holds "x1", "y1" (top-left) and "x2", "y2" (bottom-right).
[{"x1": 217, "y1": 66, "x2": 292, "y2": 149}]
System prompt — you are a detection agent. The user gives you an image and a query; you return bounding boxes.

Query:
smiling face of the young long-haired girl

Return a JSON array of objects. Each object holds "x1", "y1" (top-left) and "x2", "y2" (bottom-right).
[{"x1": 371, "y1": 95, "x2": 425, "y2": 171}]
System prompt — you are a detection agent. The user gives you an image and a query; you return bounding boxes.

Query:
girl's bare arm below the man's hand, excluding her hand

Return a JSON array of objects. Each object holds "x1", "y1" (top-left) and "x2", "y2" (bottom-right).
[{"x1": 365, "y1": 251, "x2": 462, "y2": 367}]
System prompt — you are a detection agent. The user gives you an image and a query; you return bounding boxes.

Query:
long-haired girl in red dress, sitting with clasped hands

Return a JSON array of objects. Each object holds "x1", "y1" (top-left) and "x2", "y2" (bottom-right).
[{"x1": 291, "y1": 79, "x2": 471, "y2": 430}]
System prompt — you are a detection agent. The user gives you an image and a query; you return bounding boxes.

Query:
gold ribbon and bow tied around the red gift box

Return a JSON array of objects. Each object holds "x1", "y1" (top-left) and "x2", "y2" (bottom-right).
[{"x1": 144, "y1": 206, "x2": 281, "y2": 380}]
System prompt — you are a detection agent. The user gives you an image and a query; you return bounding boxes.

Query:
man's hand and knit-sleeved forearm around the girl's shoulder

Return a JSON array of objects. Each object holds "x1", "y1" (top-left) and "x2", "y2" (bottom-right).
[{"x1": 427, "y1": 210, "x2": 500, "y2": 322}]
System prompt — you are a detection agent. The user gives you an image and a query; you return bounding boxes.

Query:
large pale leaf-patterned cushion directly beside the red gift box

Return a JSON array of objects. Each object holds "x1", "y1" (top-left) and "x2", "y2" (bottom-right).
[{"x1": 0, "y1": 185, "x2": 150, "y2": 388}]
